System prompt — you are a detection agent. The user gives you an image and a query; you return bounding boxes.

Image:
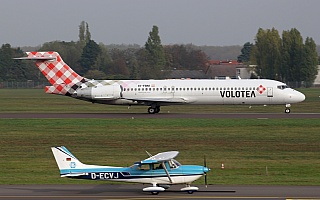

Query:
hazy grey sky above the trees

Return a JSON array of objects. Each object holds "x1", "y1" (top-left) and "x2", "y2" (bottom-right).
[{"x1": 0, "y1": 0, "x2": 320, "y2": 47}]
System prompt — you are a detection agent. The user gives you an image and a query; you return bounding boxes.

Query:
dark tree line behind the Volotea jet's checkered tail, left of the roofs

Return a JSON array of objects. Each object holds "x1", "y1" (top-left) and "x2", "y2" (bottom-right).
[{"x1": 0, "y1": 22, "x2": 208, "y2": 81}]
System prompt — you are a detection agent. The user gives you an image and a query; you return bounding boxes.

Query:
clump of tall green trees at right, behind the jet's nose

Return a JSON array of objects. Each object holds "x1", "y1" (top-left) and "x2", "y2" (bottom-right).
[{"x1": 238, "y1": 28, "x2": 320, "y2": 87}]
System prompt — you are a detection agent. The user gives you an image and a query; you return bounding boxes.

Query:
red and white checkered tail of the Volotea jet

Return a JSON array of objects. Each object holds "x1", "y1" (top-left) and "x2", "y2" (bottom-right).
[{"x1": 17, "y1": 51, "x2": 85, "y2": 96}]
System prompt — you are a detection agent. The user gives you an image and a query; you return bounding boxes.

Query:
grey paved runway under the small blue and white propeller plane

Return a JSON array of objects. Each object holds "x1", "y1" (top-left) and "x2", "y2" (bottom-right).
[{"x1": 0, "y1": 184, "x2": 320, "y2": 200}]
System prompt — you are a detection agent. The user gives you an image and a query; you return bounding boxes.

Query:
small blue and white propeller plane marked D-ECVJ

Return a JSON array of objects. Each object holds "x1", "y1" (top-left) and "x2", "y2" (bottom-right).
[{"x1": 51, "y1": 146, "x2": 210, "y2": 194}]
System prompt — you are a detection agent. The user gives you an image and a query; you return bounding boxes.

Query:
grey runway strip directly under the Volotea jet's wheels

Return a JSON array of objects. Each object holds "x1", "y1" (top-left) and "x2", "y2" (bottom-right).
[{"x1": 0, "y1": 113, "x2": 320, "y2": 119}]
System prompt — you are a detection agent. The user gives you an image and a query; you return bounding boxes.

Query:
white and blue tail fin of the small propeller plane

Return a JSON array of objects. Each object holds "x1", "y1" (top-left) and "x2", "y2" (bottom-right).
[{"x1": 51, "y1": 146, "x2": 86, "y2": 177}]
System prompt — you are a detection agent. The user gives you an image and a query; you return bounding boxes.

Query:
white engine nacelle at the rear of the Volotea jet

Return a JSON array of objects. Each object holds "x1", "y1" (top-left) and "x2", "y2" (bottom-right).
[{"x1": 76, "y1": 85, "x2": 122, "y2": 100}]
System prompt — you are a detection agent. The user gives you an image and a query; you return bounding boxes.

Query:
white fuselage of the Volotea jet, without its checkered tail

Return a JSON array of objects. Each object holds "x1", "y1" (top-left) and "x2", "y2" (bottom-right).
[{"x1": 77, "y1": 79, "x2": 305, "y2": 105}]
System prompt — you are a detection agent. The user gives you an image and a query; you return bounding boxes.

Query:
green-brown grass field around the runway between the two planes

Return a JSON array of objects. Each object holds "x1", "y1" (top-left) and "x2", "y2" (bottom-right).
[{"x1": 0, "y1": 89, "x2": 320, "y2": 185}]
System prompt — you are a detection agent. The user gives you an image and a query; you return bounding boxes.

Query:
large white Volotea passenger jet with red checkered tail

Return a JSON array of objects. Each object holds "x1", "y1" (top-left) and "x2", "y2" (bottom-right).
[{"x1": 15, "y1": 52, "x2": 305, "y2": 114}]
